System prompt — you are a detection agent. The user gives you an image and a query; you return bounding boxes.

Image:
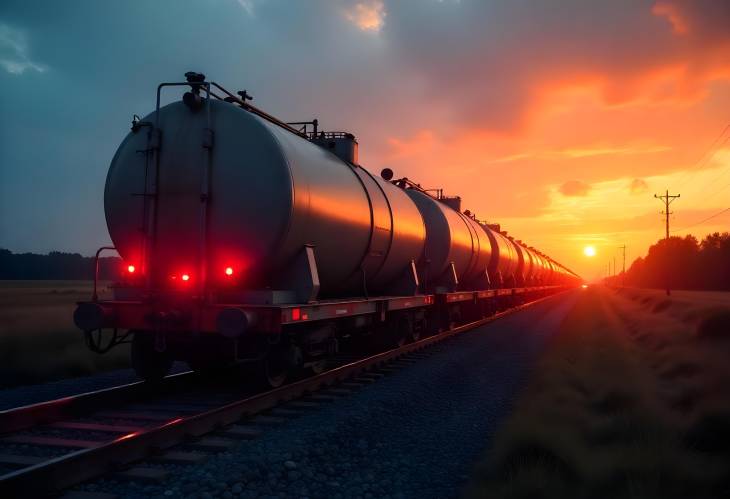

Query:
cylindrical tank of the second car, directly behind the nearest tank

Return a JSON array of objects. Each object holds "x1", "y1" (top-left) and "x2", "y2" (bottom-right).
[{"x1": 405, "y1": 189, "x2": 491, "y2": 289}]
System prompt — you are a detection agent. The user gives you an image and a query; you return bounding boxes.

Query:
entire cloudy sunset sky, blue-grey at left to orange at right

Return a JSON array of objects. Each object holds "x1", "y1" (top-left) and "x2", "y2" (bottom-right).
[{"x1": 0, "y1": 0, "x2": 730, "y2": 279}]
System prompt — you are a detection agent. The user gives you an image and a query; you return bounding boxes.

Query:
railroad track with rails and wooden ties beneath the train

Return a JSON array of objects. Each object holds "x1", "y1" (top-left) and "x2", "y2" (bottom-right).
[{"x1": 0, "y1": 295, "x2": 555, "y2": 497}]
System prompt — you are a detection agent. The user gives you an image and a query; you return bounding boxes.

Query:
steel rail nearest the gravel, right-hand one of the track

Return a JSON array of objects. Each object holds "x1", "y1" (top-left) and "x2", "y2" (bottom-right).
[{"x1": 0, "y1": 291, "x2": 565, "y2": 497}]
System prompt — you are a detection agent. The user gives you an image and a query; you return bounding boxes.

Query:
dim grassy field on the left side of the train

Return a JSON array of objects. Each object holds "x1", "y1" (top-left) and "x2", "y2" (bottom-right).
[{"x1": 0, "y1": 281, "x2": 129, "y2": 388}]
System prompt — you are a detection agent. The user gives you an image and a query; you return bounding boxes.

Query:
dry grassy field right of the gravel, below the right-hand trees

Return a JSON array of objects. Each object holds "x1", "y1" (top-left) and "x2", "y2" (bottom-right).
[{"x1": 465, "y1": 288, "x2": 730, "y2": 498}]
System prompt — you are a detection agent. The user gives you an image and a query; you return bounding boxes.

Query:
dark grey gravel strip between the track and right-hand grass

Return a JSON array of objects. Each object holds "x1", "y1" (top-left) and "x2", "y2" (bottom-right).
[{"x1": 68, "y1": 293, "x2": 576, "y2": 498}]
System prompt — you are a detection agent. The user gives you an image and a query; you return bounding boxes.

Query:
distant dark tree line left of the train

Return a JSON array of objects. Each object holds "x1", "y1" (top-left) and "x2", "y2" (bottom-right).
[{"x1": 0, "y1": 248, "x2": 122, "y2": 280}]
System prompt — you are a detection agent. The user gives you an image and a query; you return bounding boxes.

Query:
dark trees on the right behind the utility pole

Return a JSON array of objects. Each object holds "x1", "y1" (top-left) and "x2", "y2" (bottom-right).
[{"x1": 608, "y1": 232, "x2": 730, "y2": 291}]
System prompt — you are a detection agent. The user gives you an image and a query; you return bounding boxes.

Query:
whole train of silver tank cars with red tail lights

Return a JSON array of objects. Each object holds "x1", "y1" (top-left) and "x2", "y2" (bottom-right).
[{"x1": 74, "y1": 72, "x2": 581, "y2": 387}]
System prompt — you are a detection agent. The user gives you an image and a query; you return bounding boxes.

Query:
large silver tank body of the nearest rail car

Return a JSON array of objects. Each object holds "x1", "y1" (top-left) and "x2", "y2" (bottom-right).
[{"x1": 104, "y1": 101, "x2": 426, "y2": 294}]
